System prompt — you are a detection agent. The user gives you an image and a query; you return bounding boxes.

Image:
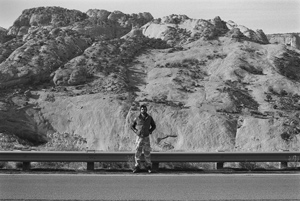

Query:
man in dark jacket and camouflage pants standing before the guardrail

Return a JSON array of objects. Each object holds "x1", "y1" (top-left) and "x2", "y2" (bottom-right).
[{"x1": 131, "y1": 105, "x2": 156, "y2": 173}]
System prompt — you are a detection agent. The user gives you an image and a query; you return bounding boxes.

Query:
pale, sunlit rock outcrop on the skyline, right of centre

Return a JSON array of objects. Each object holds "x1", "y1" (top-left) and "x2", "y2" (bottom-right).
[{"x1": 143, "y1": 15, "x2": 269, "y2": 45}]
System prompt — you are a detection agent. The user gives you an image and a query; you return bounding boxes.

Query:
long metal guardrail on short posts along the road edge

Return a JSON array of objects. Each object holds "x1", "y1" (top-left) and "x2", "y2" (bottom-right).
[{"x1": 0, "y1": 151, "x2": 300, "y2": 170}]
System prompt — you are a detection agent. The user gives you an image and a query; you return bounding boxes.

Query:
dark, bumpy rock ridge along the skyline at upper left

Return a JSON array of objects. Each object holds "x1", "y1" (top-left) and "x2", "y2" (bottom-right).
[{"x1": 8, "y1": 7, "x2": 153, "y2": 39}]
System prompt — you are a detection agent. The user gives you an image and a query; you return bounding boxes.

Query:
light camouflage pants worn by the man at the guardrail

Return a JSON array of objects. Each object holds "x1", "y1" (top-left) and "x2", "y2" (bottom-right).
[{"x1": 135, "y1": 137, "x2": 151, "y2": 166}]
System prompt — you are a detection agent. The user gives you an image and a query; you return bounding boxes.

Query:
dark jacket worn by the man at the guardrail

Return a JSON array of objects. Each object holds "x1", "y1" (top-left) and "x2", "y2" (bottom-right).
[{"x1": 131, "y1": 114, "x2": 156, "y2": 137}]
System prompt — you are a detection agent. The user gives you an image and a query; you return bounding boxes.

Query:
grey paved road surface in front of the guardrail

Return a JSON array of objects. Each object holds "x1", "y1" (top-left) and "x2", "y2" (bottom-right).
[{"x1": 0, "y1": 174, "x2": 300, "y2": 200}]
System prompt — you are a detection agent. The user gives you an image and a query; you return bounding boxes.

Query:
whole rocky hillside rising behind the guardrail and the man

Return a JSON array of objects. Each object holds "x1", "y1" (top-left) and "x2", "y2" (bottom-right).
[{"x1": 0, "y1": 7, "x2": 300, "y2": 151}]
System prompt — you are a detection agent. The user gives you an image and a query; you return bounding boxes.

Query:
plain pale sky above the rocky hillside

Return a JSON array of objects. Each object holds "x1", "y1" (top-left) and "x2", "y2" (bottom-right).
[{"x1": 0, "y1": 0, "x2": 300, "y2": 34}]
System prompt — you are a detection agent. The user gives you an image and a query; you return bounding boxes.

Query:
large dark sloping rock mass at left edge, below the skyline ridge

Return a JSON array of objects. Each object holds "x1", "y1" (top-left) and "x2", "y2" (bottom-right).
[{"x1": 0, "y1": 27, "x2": 92, "y2": 88}]
